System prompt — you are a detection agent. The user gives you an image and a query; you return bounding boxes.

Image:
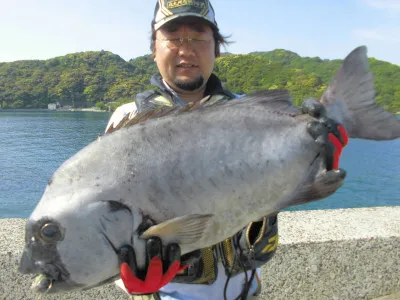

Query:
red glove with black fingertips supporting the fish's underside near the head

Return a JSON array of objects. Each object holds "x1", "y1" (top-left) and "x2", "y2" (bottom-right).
[{"x1": 118, "y1": 237, "x2": 186, "y2": 294}]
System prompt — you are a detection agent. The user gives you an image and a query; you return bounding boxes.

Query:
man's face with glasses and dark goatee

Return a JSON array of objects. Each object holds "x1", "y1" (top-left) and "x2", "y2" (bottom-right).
[{"x1": 154, "y1": 18, "x2": 215, "y2": 92}]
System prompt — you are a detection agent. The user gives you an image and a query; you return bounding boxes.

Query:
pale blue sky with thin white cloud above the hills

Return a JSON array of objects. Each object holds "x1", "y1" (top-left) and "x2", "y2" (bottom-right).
[{"x1": 0, "y1": 0, "x2": 400, "y2": 65}]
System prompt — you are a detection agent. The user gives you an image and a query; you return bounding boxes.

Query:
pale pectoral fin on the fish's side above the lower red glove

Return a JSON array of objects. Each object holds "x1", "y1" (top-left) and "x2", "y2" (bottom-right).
[{"x1": 141, "y1": 214, "x2": 214, "y2": 245}]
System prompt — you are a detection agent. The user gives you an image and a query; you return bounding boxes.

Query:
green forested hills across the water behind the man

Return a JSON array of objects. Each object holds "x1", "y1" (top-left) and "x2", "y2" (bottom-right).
[{"x1": 0, "y1": 49, "x2": 400, "y2": 112}]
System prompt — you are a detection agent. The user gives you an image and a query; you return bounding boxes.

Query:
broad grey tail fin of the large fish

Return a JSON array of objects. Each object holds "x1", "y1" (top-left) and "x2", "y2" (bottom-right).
[{"x1": 321, "y1": 46, "x2": 400, "y2": 140}]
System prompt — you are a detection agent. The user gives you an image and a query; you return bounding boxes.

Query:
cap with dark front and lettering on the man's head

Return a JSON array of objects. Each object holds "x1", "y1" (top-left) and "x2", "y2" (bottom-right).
[{"x1": 153, "y1": 0, "x2": 218, "y2": 30}]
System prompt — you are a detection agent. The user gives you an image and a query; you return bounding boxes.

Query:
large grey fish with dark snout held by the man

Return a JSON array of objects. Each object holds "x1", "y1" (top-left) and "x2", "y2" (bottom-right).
[{"x1": 20, "y1": 47, "x2": 400, "y2": 292}]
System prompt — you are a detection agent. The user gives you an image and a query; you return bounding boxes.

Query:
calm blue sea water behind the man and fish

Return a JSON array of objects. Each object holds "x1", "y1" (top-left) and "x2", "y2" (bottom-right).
[{"x1": 0, "y1": 110, "x2": 400, "y2": 218}]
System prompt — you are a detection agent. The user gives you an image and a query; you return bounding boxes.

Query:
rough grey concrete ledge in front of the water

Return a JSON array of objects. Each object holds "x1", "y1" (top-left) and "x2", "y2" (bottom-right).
[{"x1": 0, "y1": 207, "x2": 400, "y2": 300}]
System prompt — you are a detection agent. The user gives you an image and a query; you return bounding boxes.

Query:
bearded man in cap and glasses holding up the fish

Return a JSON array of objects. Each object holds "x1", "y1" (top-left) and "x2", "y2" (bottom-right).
[{"x1": 106, "y1": 0, "x2": 346, "y2": 299}]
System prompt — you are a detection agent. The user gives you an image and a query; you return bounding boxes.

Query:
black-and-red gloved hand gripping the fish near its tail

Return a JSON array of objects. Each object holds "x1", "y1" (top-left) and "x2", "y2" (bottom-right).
[{"x1": 302, "y1": 99, "x2": 349, "y2": 171}]
